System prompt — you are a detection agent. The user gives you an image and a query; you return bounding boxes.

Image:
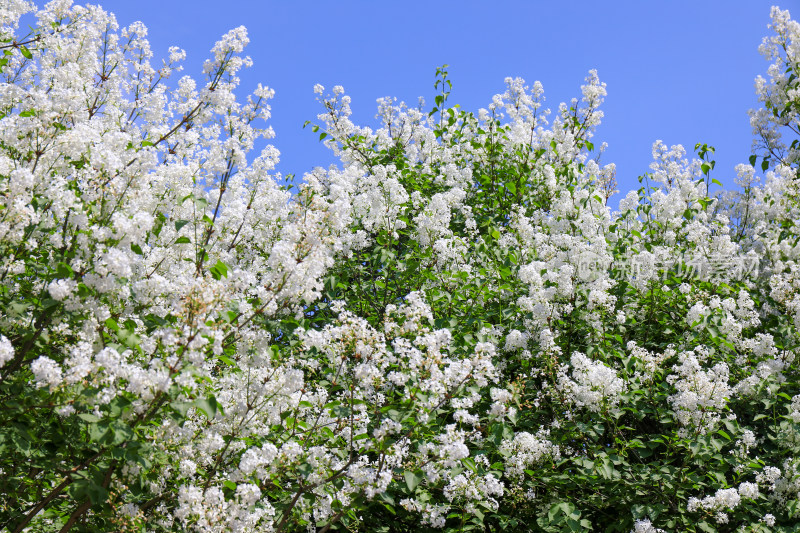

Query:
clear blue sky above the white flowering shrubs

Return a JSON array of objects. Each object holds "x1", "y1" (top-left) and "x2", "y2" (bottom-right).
[{"x1": 99, "y1": 0, "x2": 784, "y2": 205}]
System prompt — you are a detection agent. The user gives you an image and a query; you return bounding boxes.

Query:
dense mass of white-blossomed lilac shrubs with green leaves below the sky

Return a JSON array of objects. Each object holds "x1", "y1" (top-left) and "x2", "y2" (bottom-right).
[{"x1": 0, "y1": 0, "x2": 800, "y2": 533}]
